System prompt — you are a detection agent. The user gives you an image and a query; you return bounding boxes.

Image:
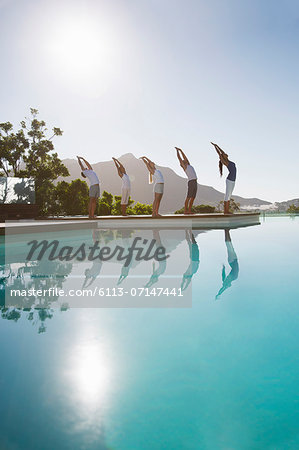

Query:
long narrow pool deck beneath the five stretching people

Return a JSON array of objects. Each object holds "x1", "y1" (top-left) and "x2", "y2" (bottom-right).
[{"x1": 0, "y1": 213, "x2": 260, "y2": 234}]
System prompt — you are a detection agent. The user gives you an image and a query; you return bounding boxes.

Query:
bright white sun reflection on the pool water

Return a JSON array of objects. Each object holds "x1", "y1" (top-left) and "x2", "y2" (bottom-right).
[{"x1": 57, "y1": 320, "x2": 116, "y2": 449}]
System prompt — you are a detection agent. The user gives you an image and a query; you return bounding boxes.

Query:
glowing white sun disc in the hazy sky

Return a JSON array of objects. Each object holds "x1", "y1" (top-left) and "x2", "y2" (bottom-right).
[{"x1": 46, "y1": 15, "x2": 119, "y2": 93}]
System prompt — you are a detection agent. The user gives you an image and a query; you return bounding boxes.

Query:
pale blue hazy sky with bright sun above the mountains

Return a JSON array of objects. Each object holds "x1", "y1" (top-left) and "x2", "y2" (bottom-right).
[{"x1": 0, "y1": 0, "x2": 299, "y2": 202}]
